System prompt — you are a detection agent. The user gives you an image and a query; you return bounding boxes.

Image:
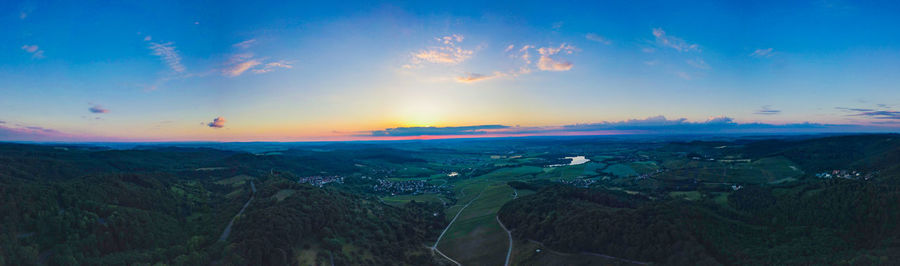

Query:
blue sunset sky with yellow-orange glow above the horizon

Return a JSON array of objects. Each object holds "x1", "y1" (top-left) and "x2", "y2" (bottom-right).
[{"x1": 0, "y1": 0, "x2": 900, "y2": 142}]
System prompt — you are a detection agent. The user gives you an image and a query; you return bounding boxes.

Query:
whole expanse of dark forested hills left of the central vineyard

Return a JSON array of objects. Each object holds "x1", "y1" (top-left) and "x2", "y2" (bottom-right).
[{"x1": 0, "y1": 143, "x2": 445, "y2": 265}]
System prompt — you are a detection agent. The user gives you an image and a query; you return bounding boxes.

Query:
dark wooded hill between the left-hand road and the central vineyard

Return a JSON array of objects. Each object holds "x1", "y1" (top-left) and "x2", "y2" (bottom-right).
[{"x1": 226, "y1": 180, "x2": 445, "y2": 265}]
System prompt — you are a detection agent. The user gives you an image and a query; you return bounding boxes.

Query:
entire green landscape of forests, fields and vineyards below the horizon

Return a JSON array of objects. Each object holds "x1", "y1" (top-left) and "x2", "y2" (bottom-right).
[{"x1": 0, "y1": 135, "x2": 900, "y2": 265}]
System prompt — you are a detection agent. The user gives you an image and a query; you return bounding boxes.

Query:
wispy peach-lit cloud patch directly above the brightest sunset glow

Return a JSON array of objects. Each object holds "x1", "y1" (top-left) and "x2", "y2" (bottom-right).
[{"x1": 404, "y1": 34, "x2": 474, "y2": 68}]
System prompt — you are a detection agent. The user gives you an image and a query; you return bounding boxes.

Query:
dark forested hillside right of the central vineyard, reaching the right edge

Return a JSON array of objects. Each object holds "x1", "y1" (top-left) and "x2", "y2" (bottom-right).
[{"x1": 498, "y1": 134, "x2": 900, "y2": 265}]
